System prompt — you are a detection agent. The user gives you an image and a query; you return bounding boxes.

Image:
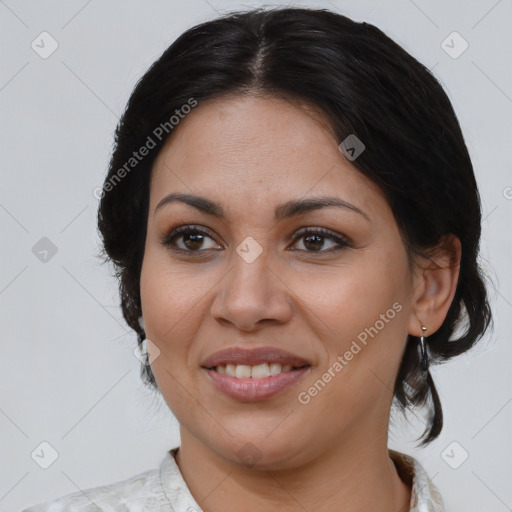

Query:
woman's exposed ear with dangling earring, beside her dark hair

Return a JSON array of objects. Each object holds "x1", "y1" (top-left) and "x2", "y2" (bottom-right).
[{"x1": 409, "y1": 234, "x2": 461, "y2": 337}]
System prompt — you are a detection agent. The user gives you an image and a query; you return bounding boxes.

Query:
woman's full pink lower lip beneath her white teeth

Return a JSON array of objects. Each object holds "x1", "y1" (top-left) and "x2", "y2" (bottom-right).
[{"x1": 203, "y1": 366, "x2": 311, "y2": 402}]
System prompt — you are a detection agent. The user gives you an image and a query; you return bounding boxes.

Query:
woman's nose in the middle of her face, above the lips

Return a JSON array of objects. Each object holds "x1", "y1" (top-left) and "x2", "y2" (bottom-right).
[{"x1": 211, "y1": 249, "x2": 293, "y2": 331}]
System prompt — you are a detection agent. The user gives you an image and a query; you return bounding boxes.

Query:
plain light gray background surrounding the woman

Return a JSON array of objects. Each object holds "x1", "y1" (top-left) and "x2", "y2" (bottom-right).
[{"x1": 0, "y1": 0, "x2": 512, "y2": 512}]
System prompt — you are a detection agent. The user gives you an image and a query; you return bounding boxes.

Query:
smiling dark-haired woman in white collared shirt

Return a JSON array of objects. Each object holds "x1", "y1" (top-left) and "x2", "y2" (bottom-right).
[{"x1": 26, "y1": 8, "x2": 491, "y2": 512}]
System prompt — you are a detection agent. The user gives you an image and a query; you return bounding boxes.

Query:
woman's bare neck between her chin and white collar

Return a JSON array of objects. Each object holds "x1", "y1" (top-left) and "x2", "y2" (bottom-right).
[{"x1": 176, "y1": 429, "x2": 411, "y2": 512}]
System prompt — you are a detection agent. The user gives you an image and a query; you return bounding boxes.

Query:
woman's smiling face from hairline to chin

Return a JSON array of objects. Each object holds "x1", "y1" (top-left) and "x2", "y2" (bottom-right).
[{"x1": 140, "y1": 93, "x2": 419, "y2": 467}]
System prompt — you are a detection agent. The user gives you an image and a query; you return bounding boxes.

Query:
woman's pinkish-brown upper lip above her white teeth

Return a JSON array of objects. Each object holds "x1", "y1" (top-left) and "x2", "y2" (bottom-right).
[{"x1": 201, "y1": 347, "x2": 310, "y2": 368}]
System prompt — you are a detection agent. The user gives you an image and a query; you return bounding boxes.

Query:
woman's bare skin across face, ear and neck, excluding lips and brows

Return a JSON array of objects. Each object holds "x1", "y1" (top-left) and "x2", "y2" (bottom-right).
[{"x1": 140, "y1": 96, "x2": 460, "y2": 512}]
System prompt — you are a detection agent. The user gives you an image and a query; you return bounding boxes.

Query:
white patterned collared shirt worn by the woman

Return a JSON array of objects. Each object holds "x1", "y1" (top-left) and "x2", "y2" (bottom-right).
[{"x1": 22, "y1": 447, "x2": 444, "y2": 512}]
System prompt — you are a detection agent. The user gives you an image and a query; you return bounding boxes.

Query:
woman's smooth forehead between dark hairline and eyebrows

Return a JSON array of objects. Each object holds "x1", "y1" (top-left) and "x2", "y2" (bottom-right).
[{"x1": 151, "y1": 96, "x2": 382, "y2": 214}]
